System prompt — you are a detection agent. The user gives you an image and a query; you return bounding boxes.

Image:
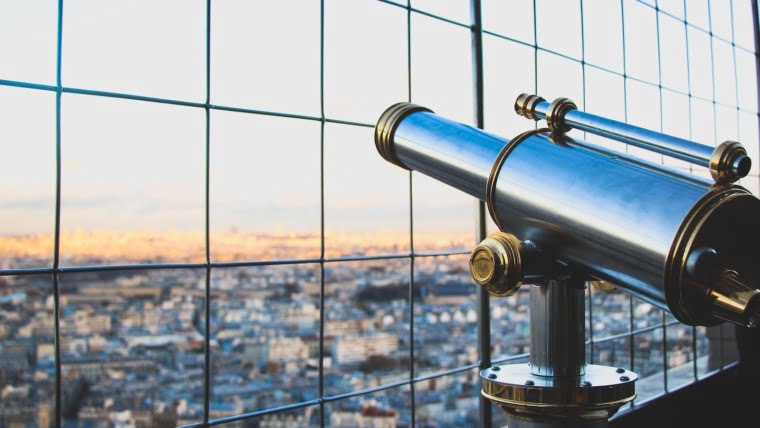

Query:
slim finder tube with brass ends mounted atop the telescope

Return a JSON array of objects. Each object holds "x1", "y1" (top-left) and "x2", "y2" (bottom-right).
[{"x1": 515, "y1": 94, "x2": 752, "y2": 183}]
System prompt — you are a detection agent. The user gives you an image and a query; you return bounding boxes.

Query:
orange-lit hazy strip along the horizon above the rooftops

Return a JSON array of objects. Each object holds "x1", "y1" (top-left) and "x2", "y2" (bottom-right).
[{"x1": 0, "y1": 230, "x2": 474, "y2": 265}]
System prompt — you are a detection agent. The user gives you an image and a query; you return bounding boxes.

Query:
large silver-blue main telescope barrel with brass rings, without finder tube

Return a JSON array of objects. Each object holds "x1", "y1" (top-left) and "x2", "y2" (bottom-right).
[{"x1": 375, "y1": 103, "x2": 760, "y2": 325}]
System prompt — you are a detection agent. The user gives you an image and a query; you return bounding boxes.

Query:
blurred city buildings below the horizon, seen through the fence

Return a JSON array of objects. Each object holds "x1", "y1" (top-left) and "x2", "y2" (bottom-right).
[{"x1": 0, "y1": 249, "x2": 700, "y2": 427}]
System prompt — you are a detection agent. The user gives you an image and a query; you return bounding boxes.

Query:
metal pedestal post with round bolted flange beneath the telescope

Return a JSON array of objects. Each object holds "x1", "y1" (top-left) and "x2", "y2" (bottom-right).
[{"x1": 480, "y1": 275, "x2": 637, "y2": 428}]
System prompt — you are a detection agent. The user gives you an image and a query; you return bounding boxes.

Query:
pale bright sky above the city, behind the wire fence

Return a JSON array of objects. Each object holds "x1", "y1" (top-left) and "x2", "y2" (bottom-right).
[{"x1": 0, "y1": 0, "x2": 760, "y2": 234}]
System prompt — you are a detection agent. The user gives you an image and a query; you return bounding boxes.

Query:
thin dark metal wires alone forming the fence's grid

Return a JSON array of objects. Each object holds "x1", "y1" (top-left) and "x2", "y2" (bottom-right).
[{"x1": 0, "y1": 0, "x2": 760, "y2": 427}]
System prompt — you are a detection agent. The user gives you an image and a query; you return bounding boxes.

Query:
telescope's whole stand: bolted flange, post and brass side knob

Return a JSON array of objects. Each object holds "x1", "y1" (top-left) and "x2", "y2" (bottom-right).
[{"x1": 470, "y1": 232, "x2": 637, "y2": 428}]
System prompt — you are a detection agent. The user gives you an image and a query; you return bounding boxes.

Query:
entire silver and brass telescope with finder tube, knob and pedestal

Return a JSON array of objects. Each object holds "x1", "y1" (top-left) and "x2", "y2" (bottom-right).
[{"x1": 375, "y1": 94, "x2": 760, "y2": 427}]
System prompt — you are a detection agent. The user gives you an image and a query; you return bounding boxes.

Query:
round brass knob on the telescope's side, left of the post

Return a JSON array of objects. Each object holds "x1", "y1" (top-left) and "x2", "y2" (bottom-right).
[{"x1": 470, "y1": 232, "x2": 523, "y2": 297}]
